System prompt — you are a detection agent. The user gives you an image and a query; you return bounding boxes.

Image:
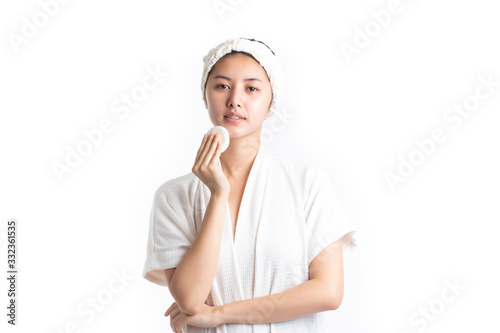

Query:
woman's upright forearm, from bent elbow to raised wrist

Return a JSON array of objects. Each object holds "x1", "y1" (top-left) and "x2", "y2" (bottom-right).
[{"x1": 169, "y1": 193, "x2": 228, "y2": 314}]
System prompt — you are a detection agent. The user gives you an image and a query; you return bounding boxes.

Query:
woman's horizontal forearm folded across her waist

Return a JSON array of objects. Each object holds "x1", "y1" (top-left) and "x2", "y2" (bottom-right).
[{"x1": 215, "y1": 280, "x2": 334, "y2": 324}]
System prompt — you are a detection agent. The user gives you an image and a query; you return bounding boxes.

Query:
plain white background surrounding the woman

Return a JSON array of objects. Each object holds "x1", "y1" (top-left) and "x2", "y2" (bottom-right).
[{"x1": 0, "y1": 0, "x2": 500, "y2": 333}]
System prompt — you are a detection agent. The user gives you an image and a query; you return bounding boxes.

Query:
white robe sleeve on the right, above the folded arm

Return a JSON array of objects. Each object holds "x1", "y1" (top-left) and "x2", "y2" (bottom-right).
[{"x1": 304, "y1": 166, "x2": 356, "y2": 265}]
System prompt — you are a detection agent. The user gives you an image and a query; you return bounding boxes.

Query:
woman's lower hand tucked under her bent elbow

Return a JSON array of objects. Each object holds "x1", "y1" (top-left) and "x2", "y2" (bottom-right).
[{"x1": 165, "y1": 302, "x2": 220, "y2": 333}]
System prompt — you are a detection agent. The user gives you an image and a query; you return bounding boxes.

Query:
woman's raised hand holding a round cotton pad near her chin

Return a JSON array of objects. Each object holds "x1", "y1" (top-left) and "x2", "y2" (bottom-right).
[{"x1": 191, "y1": 132, "x2": 231, "y2": 194}]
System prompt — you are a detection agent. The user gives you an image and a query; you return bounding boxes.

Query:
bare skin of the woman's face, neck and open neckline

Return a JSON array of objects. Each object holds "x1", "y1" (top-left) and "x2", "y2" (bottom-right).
[{"x1": 206, "y1": 54, "x2": 272, "y2": 240}]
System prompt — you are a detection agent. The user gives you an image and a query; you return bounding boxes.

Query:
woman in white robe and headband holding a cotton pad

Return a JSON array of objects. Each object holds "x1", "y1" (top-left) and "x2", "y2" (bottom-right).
[{"x1": 143, "y1": 38, "x2": 355, "y2": 332}]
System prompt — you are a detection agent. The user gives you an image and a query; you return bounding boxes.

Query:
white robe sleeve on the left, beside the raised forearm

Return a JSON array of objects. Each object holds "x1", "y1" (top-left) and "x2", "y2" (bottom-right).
[{"x1": 142, "y1": 183, "x2": 194, "y2": 286}]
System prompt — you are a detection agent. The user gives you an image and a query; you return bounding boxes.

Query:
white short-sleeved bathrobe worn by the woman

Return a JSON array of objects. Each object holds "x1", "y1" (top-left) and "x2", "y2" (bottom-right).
[{"x1": 143, "y1": 145, "x2": 355, "y2": 333}]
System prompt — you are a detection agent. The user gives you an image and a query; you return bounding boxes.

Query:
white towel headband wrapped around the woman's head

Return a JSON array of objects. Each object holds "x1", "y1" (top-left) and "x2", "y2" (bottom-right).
[{"x1": 201, "y1": 37, "x2": 282, "y2": 118}]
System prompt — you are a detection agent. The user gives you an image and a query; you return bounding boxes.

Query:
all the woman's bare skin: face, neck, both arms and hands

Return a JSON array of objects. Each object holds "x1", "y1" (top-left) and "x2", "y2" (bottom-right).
[{"x1": 164, "y1": 54, "x2": 344, "y2": 333}]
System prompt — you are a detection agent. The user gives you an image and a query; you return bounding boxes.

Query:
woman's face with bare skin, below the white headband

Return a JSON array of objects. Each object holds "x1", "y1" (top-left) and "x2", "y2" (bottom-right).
[{"x1": 205, "y1": 53, "x2": 272, "y2": 138}]
